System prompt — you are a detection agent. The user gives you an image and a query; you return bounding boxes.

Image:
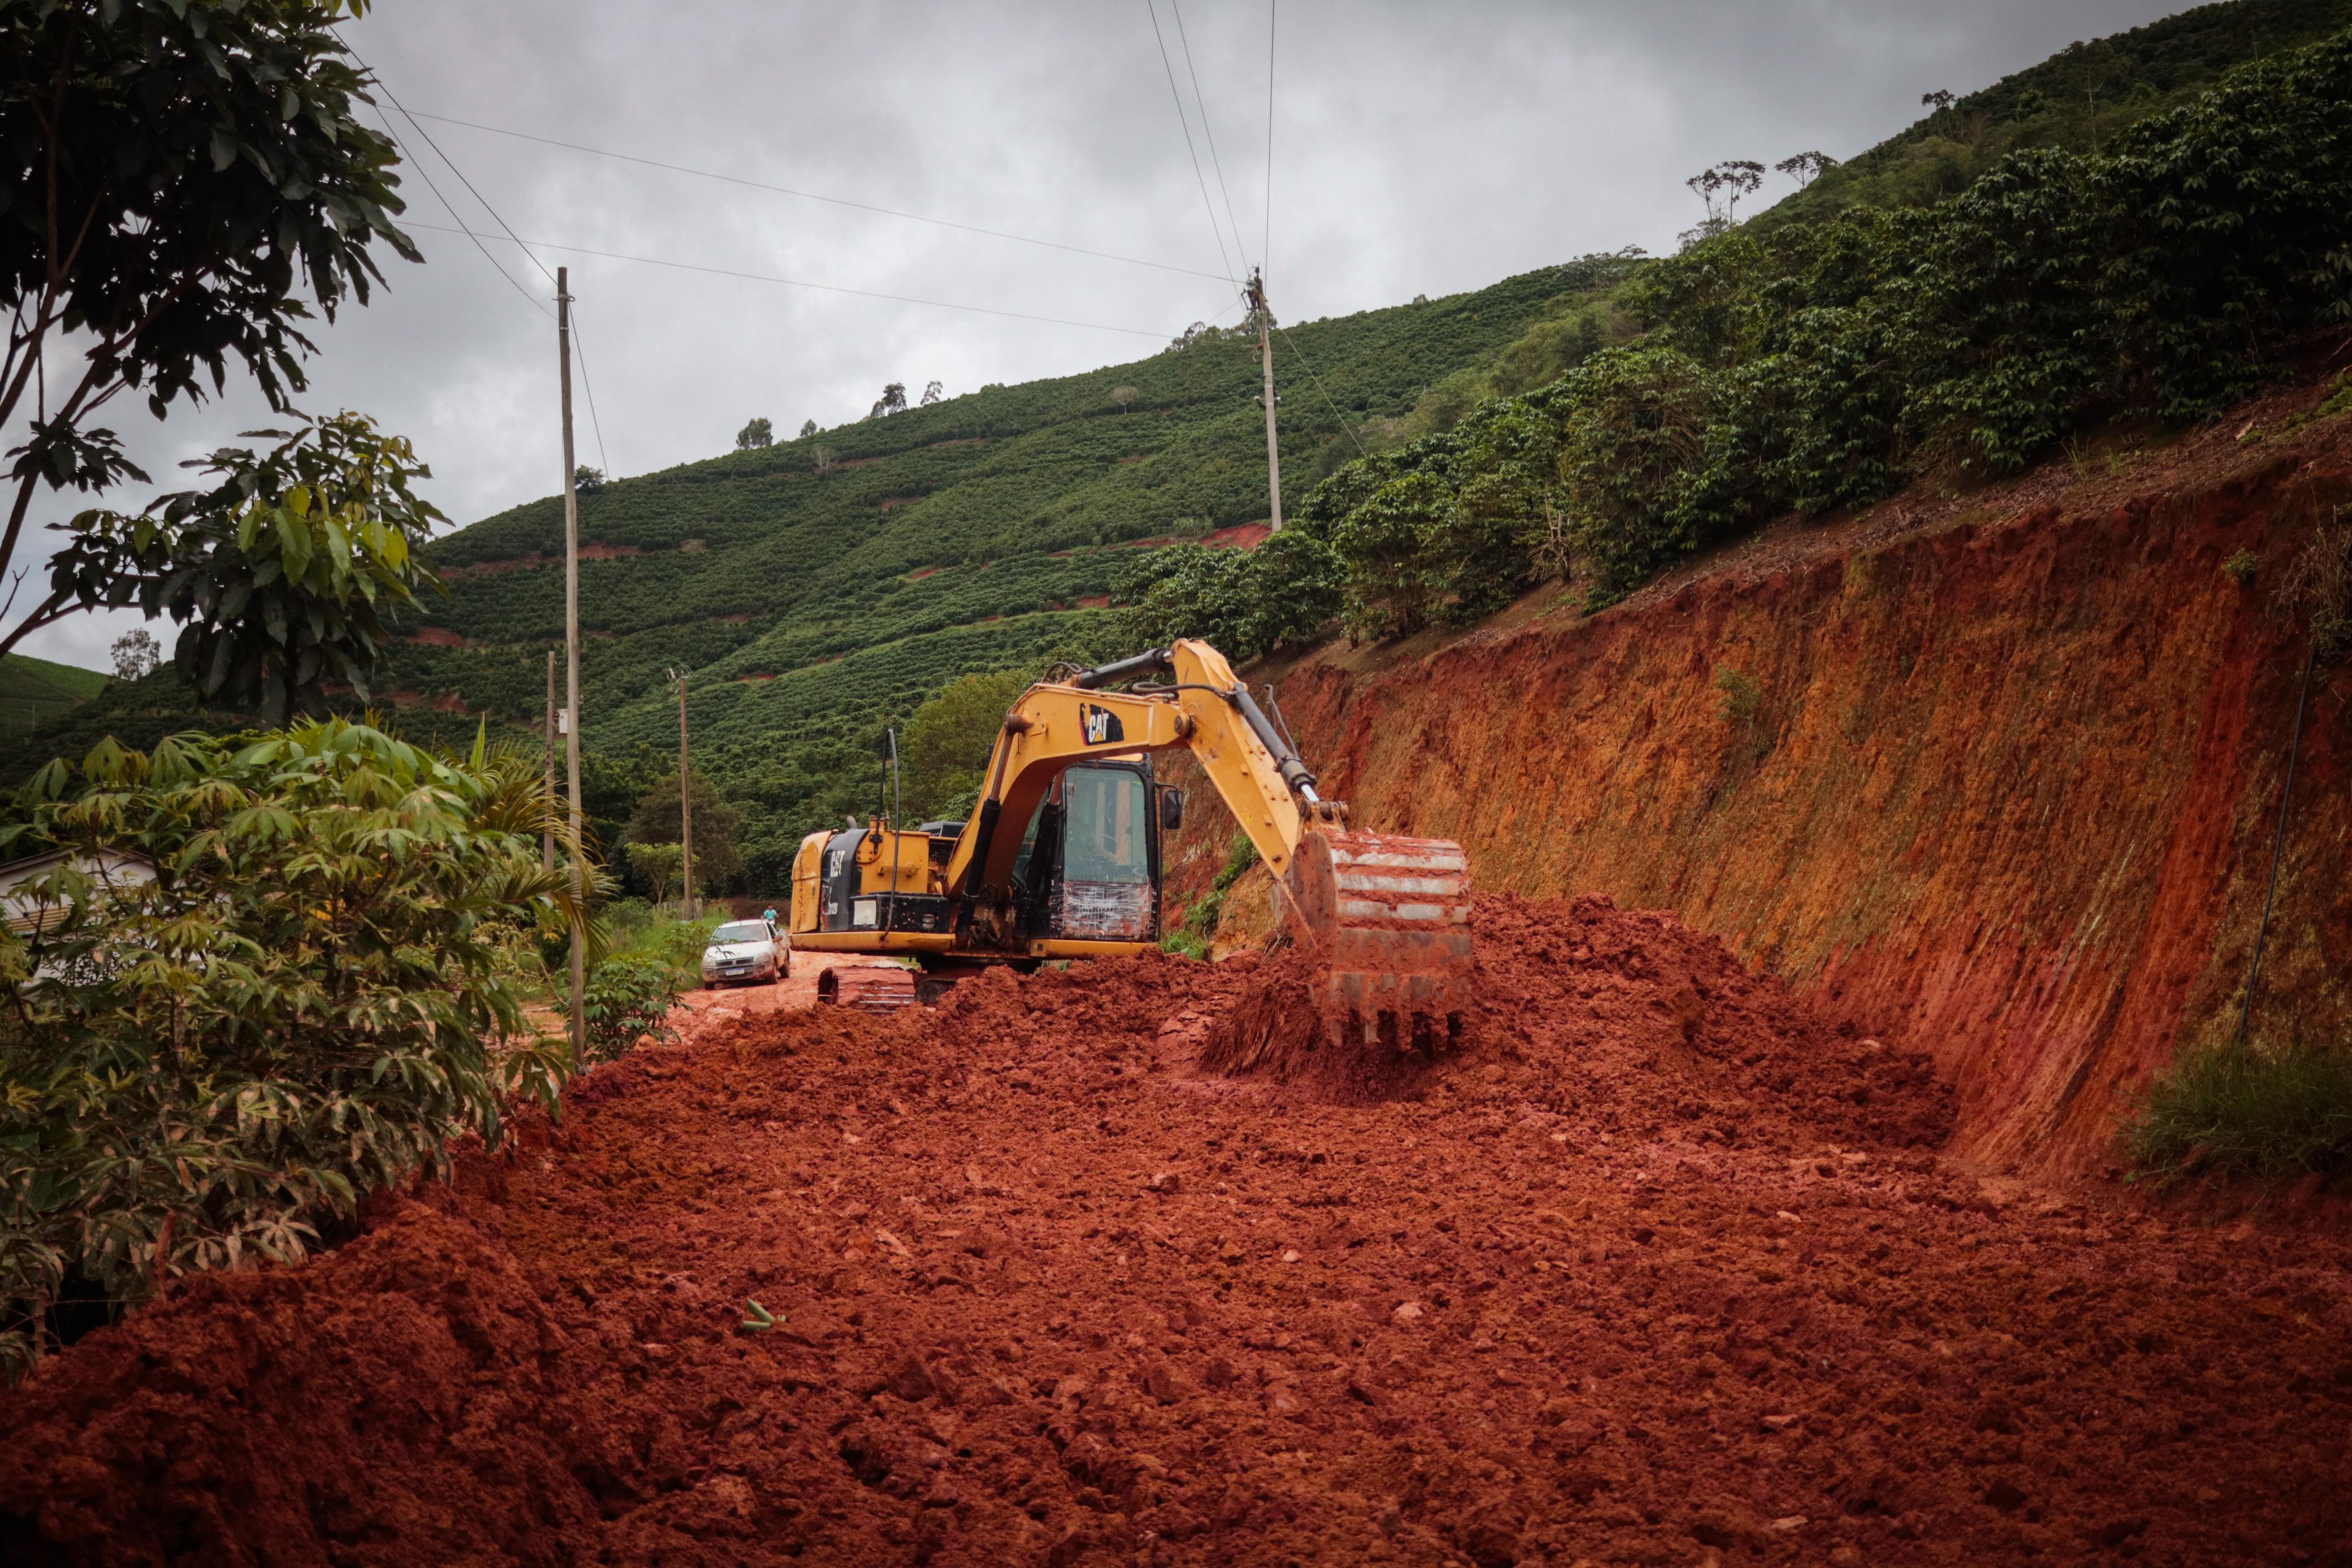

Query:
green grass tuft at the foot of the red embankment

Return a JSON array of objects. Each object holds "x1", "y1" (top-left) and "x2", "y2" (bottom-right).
[{"x1": 2124, "y1": 1041, "x2": 2352, "y2": 1187}]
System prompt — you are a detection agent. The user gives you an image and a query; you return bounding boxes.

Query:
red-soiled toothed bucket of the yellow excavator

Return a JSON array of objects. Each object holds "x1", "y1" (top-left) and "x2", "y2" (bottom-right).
[{"x1": 1287, "y1": 825, "x2": 1470, "y2": 1055}]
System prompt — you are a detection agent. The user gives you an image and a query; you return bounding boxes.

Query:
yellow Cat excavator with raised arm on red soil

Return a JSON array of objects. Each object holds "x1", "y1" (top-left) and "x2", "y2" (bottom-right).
[{"x1": 790, "y1": 639, "x2": 1470, "y2": 1055}]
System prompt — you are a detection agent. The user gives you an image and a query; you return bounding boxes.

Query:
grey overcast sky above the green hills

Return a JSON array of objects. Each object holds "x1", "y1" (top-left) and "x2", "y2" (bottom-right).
[{"x1": 10, "y1": 0, "x2": 2182, "y2": 668}]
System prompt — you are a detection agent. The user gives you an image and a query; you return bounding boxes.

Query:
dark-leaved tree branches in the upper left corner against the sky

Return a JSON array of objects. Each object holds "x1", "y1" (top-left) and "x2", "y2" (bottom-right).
[{"x1": 0, "y1": 0, "x2": 421, "y2": 668}]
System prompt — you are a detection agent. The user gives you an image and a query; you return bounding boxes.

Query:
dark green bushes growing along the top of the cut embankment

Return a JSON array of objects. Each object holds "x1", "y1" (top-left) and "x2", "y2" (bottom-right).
[{"x1": 1185, "y1": 21, "x2": 2352, "y2": 653}]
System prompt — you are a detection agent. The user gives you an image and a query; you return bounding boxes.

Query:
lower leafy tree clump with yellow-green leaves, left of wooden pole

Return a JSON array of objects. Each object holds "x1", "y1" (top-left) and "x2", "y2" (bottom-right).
[{"x1": 49, "y1": 414, "x2": 447, "y2": 724}]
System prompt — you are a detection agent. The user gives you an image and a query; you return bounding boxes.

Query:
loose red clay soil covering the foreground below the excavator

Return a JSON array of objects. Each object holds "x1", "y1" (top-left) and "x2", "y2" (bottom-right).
[{"x1": 0, "y1": 898, "x2": 2352, "y2": 1568}]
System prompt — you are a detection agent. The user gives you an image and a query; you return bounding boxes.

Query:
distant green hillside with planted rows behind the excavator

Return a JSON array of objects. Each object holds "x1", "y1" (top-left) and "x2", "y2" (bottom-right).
[{"x1": 9, "y1": 263, "x2": 1623, "y2": 889}]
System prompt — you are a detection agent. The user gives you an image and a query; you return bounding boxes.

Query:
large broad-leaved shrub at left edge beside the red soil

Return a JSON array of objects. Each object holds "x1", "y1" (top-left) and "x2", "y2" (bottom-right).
[{"x1": 0, "y1": 722, "x2": 572, "y2": 1361}]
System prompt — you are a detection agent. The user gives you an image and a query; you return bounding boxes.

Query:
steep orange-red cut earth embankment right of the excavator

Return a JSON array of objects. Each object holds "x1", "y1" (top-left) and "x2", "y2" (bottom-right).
[{"x1": 1213, "y1": 404, "x2": 2352, "y2": 1171}]
